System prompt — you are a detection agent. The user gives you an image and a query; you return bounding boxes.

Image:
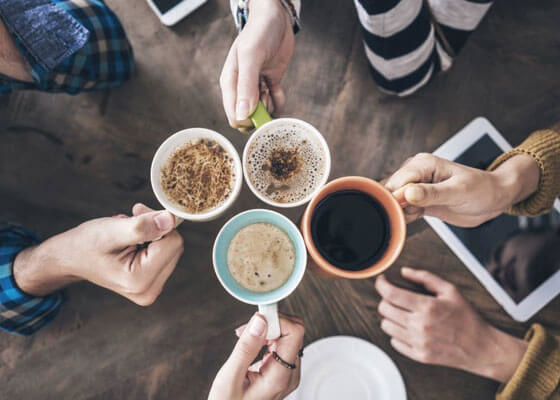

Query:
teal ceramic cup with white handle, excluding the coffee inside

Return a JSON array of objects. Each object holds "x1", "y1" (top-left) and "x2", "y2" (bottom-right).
[{"x1": 212, "y1": 209, "x2": 307, "y2": 339}]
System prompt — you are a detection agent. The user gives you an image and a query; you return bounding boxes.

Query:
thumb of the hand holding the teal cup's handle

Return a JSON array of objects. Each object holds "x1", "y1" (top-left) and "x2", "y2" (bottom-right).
[{"x1": 224, "y1": 314, "x2": 267, "y2": 383}]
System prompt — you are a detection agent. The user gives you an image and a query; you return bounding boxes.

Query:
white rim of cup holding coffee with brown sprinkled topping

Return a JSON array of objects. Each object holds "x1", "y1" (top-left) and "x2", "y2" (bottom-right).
[{"x1": 150, "y1": 128, "x2": 243, "y2": 222}]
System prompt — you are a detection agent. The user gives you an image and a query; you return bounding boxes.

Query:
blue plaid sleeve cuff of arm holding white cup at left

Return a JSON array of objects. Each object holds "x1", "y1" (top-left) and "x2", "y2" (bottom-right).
[{"x1": 0, "y1": 226, "x2": 65, "y2": 336}]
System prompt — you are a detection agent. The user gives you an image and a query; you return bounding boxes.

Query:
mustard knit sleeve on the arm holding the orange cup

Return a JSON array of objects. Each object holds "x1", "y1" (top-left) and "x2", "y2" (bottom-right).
[{"x1": 488, "y1": 130, "x2": 560, "y2": 216}]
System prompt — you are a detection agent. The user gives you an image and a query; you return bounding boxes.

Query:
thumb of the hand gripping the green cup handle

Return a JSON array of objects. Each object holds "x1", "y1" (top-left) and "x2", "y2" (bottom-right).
[{"x1": 235, "y1": 54, "x2": 261, "y2": 121}]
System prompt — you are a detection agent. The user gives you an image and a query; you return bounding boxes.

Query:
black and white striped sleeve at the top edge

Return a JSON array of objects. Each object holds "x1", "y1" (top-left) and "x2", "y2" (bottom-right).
[{"x1": 354, "y1": 0, "x2": 491, "y2": 96}]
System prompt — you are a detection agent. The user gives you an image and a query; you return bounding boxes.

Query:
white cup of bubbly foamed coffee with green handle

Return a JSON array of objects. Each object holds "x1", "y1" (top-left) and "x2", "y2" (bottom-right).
[{"x1": 243, "y1": 101, "x2": 331, "y2": 208}]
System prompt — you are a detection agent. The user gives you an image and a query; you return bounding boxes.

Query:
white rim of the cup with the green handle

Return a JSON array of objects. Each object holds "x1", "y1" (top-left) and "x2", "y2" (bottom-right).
[{"x1": 242, "y1": 118, "x2": 331, "y2": 208}]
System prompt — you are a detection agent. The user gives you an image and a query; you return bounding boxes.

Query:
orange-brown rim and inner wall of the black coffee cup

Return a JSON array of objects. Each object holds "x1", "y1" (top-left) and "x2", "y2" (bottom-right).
[{"x1": 301, "y1": 176, "x2": 406, "y2": 279}]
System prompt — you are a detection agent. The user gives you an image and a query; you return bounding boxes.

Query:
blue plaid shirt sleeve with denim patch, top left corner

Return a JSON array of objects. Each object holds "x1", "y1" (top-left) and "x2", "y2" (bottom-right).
[{"x1": 0, "y1": 0, "x2": 134, "y2": 94}]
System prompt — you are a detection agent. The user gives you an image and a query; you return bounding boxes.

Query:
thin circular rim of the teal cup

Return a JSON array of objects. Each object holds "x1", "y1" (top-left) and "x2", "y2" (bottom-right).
[{"x1": 212, "y1": 208, "x2": 307, "y2": 305}]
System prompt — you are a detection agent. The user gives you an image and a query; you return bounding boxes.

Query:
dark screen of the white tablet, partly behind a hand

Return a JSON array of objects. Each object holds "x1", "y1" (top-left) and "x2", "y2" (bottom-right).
[{"x1": 447, "y1": 134, "x2": 560, "y2": 303}]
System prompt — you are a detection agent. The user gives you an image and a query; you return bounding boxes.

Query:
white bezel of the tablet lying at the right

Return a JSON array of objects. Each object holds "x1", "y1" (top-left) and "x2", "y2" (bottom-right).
[{"x1": 424, "y1": 117, "x2": 560, "y2": 322}]
